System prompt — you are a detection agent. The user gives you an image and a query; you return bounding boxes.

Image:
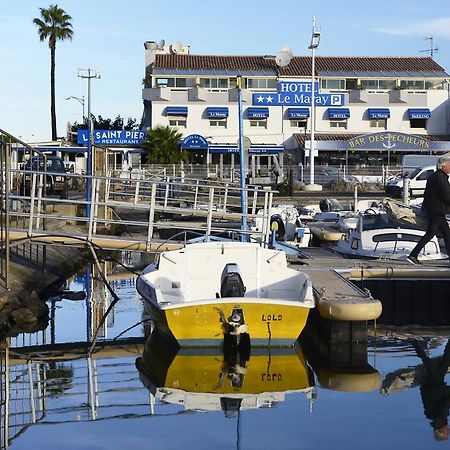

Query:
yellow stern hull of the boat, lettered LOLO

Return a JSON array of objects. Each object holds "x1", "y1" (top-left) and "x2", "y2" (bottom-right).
[{"x1": 149, "y1": 299, "x2": 310, "y2": 346}]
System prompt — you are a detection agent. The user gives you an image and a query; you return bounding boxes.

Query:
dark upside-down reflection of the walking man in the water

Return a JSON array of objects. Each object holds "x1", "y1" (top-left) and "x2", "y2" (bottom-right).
[{"x1": 413, "y1": 339, "x2": 450, "y2": 441}]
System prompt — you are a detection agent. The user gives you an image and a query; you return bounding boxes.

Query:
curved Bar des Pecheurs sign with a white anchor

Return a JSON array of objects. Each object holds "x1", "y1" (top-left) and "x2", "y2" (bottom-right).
[{"x1": 347, "y1": 131, "x2": 431, "y2": 151}]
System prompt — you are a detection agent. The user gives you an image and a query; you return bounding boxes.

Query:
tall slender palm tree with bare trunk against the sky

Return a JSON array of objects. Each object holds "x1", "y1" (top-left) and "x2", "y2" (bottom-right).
[{"x1": 33, "y1": 5, "x2": 73, "y2": 141}]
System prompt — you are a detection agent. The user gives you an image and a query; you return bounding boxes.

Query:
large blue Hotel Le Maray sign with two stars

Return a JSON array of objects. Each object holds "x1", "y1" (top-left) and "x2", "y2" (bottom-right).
[{"x1": 253, "y1": 81, "x2": 344, "y2": 106}]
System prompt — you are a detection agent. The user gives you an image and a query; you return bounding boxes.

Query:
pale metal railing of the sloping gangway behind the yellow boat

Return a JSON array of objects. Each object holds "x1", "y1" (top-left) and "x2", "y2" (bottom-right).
[{"x1": 5, "y1": 169, "x2": 274, "y2": 255}]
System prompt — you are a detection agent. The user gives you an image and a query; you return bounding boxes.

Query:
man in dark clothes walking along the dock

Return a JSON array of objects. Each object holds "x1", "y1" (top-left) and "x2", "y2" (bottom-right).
[{"x1": 407, "y1": 155, "x2": 450, "y2": 264}]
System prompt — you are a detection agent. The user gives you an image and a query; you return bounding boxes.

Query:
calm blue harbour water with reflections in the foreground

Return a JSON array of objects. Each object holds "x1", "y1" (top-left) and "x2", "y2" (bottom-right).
[{"x1": 1, "y1": 266, "x2": 450, "y2": 450}]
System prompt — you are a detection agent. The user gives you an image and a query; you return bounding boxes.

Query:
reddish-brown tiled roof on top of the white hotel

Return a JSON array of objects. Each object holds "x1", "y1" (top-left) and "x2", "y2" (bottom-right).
[{"x1": 153, "y1": 54, "x2": 444, "y2": 76}]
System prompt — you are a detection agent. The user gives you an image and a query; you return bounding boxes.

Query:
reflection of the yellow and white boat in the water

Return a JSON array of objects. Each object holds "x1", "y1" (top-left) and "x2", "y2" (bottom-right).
[{"x1": 136, "y1": 335, "x2": 314, "y2": 417}]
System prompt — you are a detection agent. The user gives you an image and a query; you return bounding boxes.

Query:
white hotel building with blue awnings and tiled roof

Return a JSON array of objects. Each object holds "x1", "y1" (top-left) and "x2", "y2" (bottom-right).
[{"x1": 142, "y1": 41, "x2": 450, "y2": 171}]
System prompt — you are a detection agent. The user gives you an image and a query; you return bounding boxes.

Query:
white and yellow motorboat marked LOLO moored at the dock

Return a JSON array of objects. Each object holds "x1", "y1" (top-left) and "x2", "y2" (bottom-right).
[{"x1": 136, "y1": 241, "x2": 314, "y2": 346}]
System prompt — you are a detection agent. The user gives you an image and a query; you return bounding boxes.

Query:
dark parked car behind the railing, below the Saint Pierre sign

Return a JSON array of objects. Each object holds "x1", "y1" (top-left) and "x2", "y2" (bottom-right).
[{"x1": 19, "y1": 155, "x2": 69, "y2": 199}]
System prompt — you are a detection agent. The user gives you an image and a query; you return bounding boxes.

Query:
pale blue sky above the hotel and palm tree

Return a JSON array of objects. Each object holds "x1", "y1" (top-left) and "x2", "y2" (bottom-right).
[{"x1": 0, "y1": 0, "x2": 450, "y2": 142}]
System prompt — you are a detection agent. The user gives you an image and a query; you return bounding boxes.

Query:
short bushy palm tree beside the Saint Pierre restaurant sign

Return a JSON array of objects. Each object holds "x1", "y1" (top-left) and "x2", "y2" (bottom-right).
[{"x1": 142, "y1": 126, "x2": 187, "y2": 164}]
